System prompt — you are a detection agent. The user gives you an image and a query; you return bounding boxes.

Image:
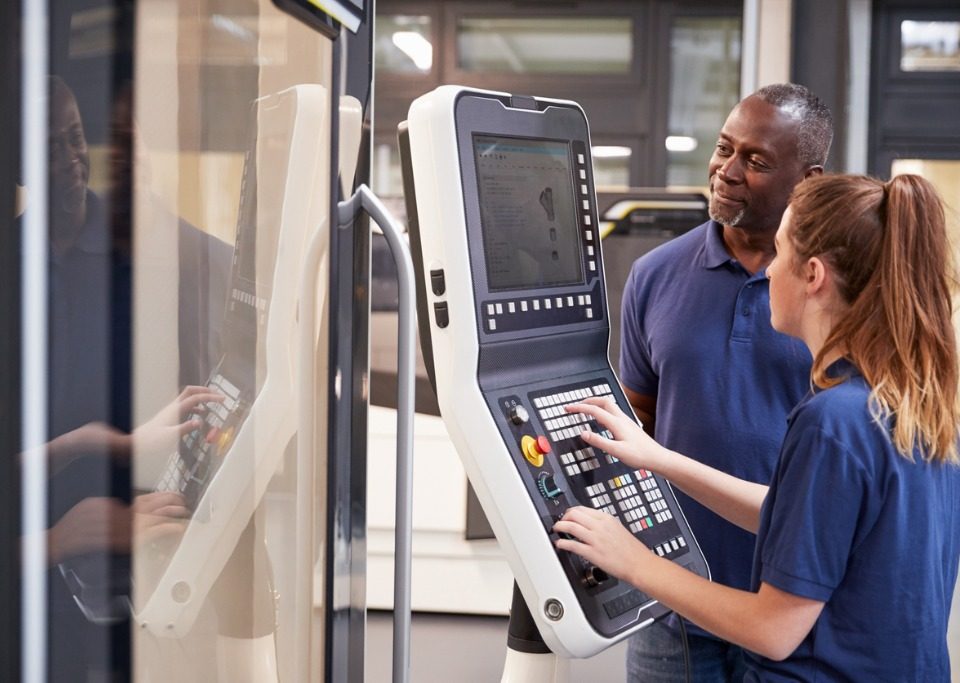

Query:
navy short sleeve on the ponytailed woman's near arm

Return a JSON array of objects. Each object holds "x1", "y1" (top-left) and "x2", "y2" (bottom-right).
[{"x1": 758, "y1": 424, "x2": 870, "y2": 602}]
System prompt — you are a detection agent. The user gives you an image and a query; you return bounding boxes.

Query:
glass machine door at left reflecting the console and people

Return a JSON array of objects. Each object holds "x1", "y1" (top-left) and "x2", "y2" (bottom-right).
[{"x1": 31, "y1": 0, "x2": 335, "y2": 683}]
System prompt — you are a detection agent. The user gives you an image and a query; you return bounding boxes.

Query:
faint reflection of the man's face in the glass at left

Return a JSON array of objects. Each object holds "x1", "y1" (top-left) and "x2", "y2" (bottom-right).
[{"x1": 50, "y1": 90, "x2": 90, "y2": 213}]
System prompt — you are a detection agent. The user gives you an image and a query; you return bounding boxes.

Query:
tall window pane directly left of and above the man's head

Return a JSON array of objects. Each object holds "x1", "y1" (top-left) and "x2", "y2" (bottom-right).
[{"x1": 664, "y1": 17, "x2": 740, "y2": 186}]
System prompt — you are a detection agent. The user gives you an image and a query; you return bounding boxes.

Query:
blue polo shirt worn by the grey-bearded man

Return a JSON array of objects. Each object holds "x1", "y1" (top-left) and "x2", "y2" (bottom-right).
[{"x1": 620, "y1": 221, "x2": 810, "y2": 604}]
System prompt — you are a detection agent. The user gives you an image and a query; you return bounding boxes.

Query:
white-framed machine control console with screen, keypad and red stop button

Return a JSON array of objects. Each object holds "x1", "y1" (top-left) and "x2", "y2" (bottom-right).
[{"x1": 400, "y1": 86, "x2": 709, "y2": 657}]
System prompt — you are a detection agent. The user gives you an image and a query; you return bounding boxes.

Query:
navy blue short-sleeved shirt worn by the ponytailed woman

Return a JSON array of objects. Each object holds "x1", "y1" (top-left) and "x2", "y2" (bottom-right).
[{"x1": 745, "y1": 361, "x2": 960, "y2": 683}]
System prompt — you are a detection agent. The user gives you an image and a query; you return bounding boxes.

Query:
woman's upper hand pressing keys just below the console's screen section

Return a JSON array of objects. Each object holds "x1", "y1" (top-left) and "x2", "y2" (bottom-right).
[{"x1": 566, "y1": 398, "x2": 670, "y2": 473}]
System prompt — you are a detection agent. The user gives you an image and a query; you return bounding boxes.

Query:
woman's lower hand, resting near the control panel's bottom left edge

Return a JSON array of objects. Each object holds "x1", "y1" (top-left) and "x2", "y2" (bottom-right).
[{"x1": 553, "y1": 507, "x2": 654, "y2": 583}]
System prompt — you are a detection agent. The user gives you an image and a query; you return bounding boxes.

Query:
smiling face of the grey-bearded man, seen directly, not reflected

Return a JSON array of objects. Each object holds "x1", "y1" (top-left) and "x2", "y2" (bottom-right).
[{"x1": 709, "y1": 96, "x2": 806, "y2": 231}]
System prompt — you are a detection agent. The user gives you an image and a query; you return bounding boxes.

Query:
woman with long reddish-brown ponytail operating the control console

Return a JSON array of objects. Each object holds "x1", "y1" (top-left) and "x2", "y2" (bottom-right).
[{"x1": 556, "y1": 176, "x2": 960, "y2": 681}]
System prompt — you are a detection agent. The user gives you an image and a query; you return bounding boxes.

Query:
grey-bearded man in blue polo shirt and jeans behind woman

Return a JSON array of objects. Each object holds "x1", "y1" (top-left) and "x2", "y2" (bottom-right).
[{"x1": 620, "y1": 84, "x2": 833, "y2": 683}]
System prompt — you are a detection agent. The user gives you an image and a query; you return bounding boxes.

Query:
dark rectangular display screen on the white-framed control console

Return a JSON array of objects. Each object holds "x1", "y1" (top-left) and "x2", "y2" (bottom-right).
[{"x1": 473, "y1": 135, "x2": 583, "y2": 291}]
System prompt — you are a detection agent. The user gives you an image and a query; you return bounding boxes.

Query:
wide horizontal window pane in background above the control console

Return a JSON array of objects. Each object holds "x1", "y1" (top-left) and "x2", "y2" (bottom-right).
[{"x1": 457, "y1": 17, "x2": 633, "y2": 74}]
